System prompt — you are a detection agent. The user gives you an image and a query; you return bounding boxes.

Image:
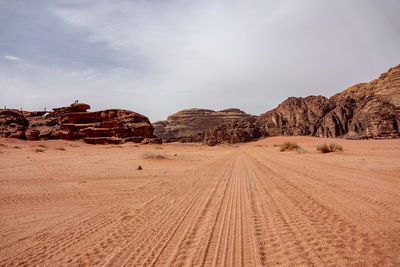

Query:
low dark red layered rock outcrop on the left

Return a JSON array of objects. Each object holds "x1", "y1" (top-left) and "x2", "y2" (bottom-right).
[{"x1": 0, "y1": 103, "x2": 161, "y2": 144}]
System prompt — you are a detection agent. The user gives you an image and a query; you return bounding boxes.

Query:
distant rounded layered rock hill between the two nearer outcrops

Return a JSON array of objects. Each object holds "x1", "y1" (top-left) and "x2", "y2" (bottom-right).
[{"x1": 153, "y1": 108, "x2": 252, "y2": 142}]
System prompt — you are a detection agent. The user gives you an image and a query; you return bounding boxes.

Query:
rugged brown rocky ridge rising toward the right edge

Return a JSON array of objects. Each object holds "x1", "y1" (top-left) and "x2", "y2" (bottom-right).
[{"x1": 203, "y1": 65, "x2": 400, "y2": 145}]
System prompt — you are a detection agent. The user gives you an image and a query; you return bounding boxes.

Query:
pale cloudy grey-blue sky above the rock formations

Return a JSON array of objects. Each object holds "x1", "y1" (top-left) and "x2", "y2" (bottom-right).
[{"x1": 0, "y1": 0, "x2": 400, "y2": 122}]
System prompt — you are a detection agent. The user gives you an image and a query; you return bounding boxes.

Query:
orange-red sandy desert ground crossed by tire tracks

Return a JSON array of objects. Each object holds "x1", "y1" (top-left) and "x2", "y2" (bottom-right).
[{"x1": 0, "y1": 137, "x2": 400, "y2": 266}]
